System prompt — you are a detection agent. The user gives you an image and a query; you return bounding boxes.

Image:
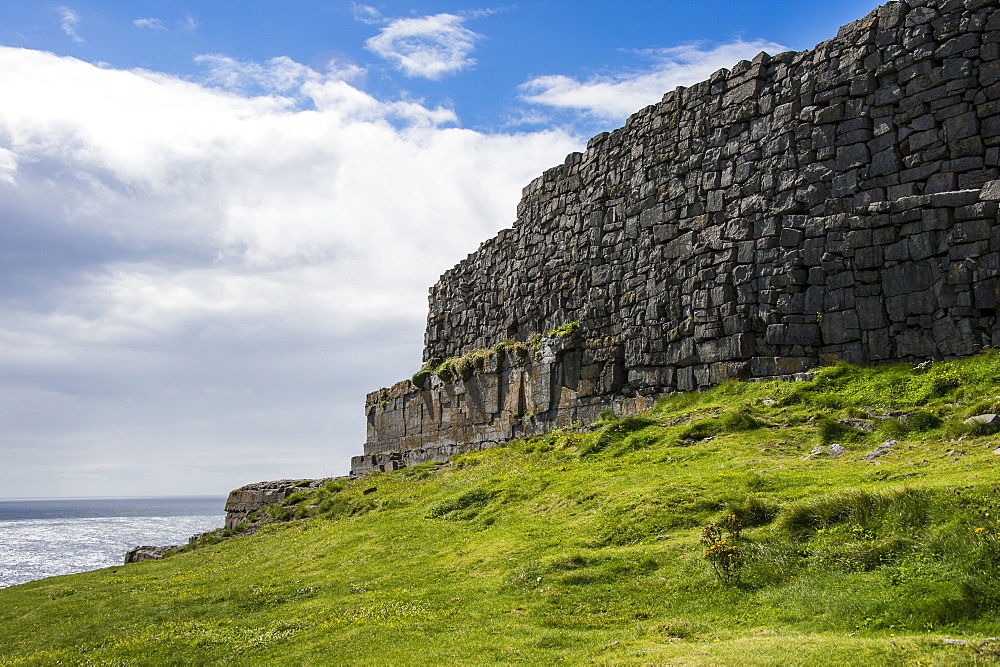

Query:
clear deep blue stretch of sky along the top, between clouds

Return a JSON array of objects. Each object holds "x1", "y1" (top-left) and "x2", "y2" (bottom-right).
[{"x1": 0, "y1": 0, "x2": 875, "y2": 132}]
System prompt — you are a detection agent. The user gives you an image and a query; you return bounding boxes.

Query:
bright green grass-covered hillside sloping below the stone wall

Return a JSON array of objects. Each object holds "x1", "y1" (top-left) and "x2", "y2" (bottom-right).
[{"x1": 0, "y1": 352, "x2": 1000, "y2": 664}]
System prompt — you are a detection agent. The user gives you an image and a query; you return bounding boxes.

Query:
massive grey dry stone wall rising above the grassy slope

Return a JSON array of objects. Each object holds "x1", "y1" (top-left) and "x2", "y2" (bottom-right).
[{"x1": 355, "y1": 0, "x2": 1000, "y2": 480}]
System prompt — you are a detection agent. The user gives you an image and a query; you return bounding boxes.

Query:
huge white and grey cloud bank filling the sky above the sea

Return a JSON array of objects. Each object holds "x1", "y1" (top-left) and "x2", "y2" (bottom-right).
[{"x1": 0, "y1": 47, "x2": 578, "y2": 496}]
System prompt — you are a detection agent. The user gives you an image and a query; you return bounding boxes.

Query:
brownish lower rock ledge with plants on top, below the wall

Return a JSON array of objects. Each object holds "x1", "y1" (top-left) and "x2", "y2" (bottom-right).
[{"x1": 351, "y1": 332, "x2": 652, "y2": 477}]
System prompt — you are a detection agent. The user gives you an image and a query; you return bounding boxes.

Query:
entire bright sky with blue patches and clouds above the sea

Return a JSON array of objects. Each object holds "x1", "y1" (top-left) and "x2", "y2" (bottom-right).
[{"x1": 0, "y1": 0, "x2": 878, "y2": 498}]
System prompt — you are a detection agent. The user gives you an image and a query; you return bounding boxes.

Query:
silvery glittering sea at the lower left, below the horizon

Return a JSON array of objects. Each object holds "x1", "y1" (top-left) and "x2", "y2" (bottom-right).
[{"x1": 0, "y1": 496, "x2": 226, "y2": 588}]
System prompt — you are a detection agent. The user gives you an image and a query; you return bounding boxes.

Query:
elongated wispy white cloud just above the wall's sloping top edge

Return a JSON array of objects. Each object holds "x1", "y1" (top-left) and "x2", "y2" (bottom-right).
[{"x1": 520, "y1": 39, "x2": 787, "y2": 119}]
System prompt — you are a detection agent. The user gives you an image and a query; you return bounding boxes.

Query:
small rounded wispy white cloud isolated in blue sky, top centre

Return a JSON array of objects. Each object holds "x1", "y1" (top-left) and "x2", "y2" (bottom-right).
[{"x1": 365, "y1": 14, "x2": 480, "y2": 80}]
